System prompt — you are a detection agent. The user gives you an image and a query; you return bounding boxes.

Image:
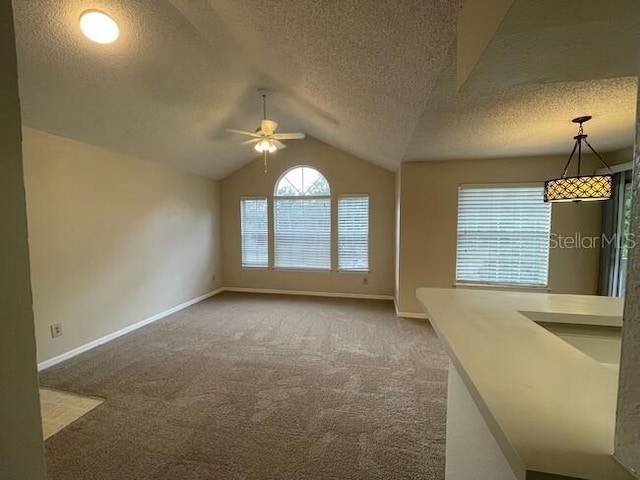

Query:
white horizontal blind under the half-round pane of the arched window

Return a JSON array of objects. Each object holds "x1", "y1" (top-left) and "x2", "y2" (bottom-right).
[{"x1": 274, "y1": 197, "x2": 331, "y2": 270}]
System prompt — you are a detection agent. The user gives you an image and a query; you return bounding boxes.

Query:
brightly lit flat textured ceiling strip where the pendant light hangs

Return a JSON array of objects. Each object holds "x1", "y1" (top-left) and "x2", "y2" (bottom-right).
[{"x1": 405, "y1": 60, "x2": 638, "y2": 161}]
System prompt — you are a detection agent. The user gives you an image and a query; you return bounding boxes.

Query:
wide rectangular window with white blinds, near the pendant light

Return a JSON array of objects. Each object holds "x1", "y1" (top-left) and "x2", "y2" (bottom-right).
[{"x1": 456, "y1": 185, "x2": 551, "y2": 286}]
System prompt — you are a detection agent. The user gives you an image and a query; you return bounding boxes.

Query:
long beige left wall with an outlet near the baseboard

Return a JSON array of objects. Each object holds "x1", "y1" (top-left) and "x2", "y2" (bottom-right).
[{"x1": 24, "y1": 129, "x2": 221, "y2": 362}]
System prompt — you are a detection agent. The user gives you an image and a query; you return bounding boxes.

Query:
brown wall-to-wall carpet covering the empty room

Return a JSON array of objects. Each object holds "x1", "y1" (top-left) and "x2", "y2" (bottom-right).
[{"x1": 41, "y1": 293, "x2": 447, "y2": 480}]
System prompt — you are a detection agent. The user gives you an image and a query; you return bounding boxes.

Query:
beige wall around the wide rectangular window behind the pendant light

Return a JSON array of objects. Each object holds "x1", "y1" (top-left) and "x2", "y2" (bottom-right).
[{"x1": 396, "y1": 156, "x2": 602, "y2": 313}]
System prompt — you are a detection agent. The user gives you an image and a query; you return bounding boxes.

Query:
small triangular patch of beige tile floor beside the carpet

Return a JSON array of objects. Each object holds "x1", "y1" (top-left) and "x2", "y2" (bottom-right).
[{"x1": 40, "y1": 388, "x2": 104, "y2": 440}]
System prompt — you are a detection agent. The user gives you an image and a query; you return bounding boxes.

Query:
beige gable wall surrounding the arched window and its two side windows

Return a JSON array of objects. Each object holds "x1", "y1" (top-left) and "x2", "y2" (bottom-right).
[{"x1": 221, "y1": 138, "x2": 395, "y2": 296}]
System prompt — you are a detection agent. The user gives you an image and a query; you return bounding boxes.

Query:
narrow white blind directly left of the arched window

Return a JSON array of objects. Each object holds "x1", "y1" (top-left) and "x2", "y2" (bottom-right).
[{"x1": 240, "y1": 198, "x2": 269, "y2": 267}]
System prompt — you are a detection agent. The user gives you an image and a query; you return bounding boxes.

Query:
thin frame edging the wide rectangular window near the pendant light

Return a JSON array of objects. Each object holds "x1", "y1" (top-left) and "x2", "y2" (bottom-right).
[{"x1": 454, "y1": 182, "x2": 553, "y2": 291}]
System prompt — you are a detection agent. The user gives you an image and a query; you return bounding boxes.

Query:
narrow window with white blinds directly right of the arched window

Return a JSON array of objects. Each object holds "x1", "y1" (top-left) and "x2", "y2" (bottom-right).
[{"x1": 338, "y1": 195, "x2": 369, "y2": 271}]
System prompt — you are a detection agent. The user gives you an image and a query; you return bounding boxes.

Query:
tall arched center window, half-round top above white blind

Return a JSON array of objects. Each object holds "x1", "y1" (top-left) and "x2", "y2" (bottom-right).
[{"x1": 274, "y1": 166, "x2": 331, "y2": 270}]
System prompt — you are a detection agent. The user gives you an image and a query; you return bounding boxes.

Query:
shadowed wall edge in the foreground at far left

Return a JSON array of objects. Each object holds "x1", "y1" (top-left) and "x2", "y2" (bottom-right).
[{"x1": 0, "y1": 2, "x2": 45, "y2": 480}]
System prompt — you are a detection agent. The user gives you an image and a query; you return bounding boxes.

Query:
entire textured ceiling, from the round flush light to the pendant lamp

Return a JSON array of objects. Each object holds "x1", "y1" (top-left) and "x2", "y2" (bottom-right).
[{"x1": 14, "y1": 0, "x2": 640, "y2": 178}]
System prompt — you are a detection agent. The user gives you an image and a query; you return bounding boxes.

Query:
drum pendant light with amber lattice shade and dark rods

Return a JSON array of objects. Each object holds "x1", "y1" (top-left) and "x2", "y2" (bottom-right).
[{"x1": 544, "y1": 115, "x2": 613, "y2": 202}]
